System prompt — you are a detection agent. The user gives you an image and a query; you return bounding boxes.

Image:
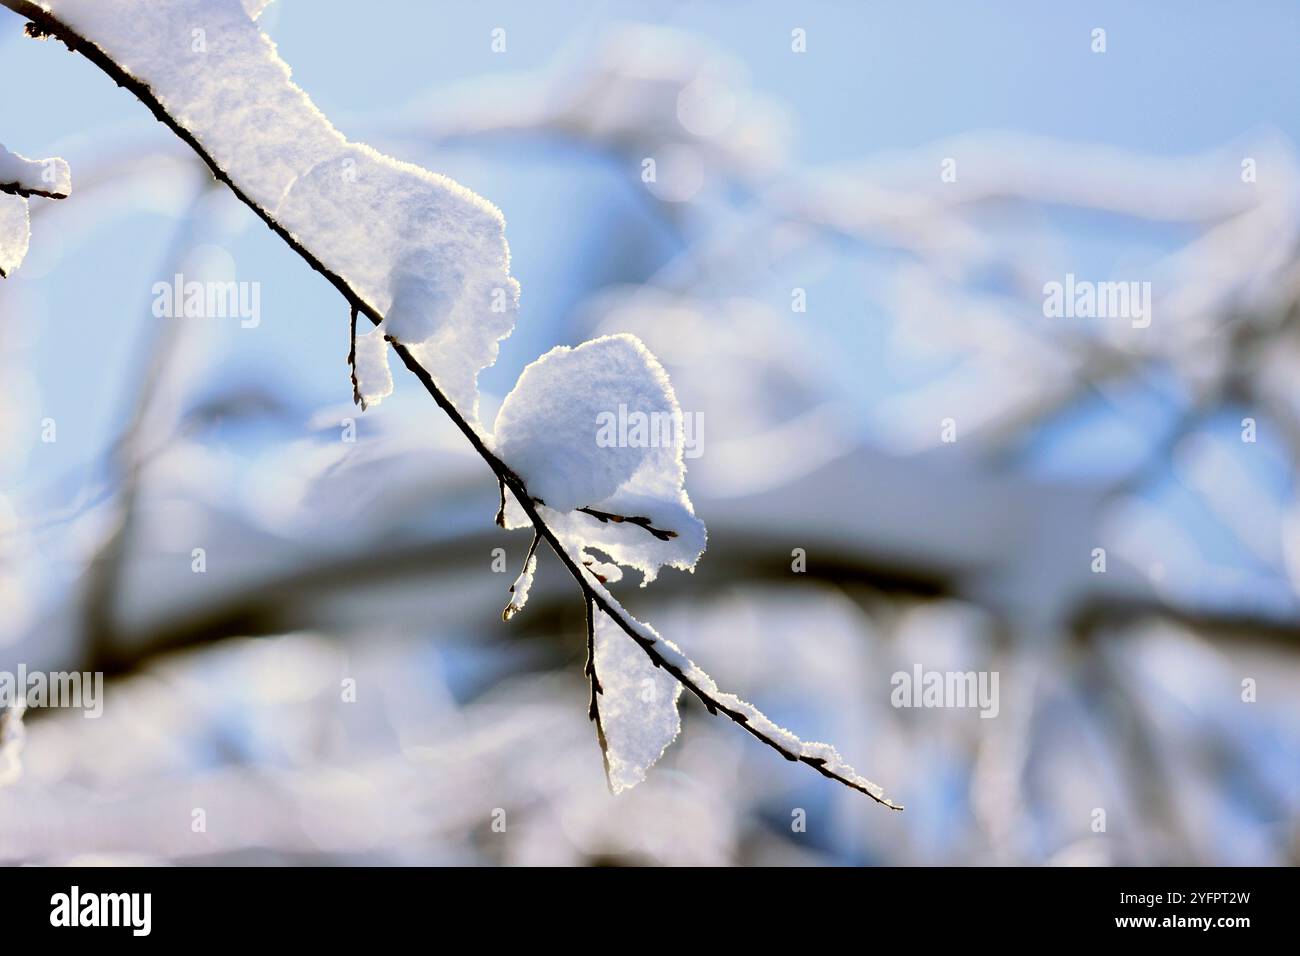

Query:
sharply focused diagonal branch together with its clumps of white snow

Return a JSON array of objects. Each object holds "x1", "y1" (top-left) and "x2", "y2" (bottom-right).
[{"x1": 0, "y1": 0, "x2": 901, "y2": 809}]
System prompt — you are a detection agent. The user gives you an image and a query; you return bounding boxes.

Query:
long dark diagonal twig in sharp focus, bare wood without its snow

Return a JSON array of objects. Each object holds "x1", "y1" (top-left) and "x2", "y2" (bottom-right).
[{"x1": 0, "y1": 0, "x2": 902, "y2": 810}]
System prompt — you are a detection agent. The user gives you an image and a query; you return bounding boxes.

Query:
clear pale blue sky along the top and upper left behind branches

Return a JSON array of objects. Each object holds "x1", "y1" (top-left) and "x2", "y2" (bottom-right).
[{"x1": 0, "y1": 0, "x2": 1300, "y2": 502}]
